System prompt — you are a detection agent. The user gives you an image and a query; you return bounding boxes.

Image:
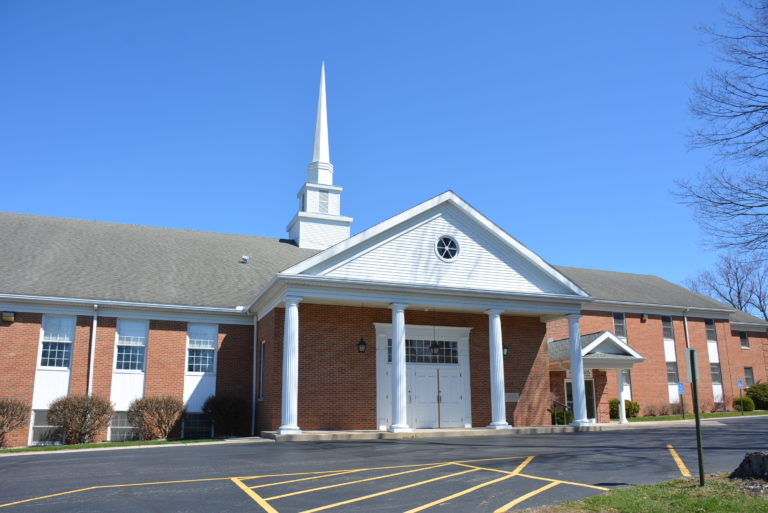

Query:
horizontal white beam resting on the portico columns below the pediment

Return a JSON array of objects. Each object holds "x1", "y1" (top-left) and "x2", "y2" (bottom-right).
[{"x1": 251, "y1": 275, "x2": 588, "y2": 319}]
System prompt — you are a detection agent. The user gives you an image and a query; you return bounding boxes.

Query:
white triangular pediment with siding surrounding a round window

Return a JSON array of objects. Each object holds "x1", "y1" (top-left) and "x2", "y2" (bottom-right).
[{"x1": 283, "y1": 192, "x2": 587, "y2": 296}]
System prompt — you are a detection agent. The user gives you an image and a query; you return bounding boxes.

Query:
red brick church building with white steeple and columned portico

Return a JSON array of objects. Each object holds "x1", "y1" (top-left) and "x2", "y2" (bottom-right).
[{"x1": 0, "y1": 67, "x2": 768, "y2": 445}]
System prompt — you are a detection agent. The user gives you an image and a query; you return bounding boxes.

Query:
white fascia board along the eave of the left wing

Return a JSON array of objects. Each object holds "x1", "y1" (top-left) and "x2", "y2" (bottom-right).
[{"x1": 0, "y1": 294, "x2": 253, "y2": 324}]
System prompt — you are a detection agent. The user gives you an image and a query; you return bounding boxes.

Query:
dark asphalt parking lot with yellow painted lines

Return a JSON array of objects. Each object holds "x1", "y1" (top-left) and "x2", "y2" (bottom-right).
[{"x1": 0, "y1": 417, "x2": 768, "y2": 513}]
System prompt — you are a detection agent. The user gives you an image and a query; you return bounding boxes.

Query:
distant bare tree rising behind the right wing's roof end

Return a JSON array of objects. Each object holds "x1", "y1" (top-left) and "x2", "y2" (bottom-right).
[{"x1": 685, "y1": 255, "x2": 768, "y2": 320}]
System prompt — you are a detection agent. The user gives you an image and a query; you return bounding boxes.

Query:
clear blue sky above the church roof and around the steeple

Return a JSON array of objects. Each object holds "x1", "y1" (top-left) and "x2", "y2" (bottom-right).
[{"x1": 0, "y1": 0, "x2": 733, "y2": 282}]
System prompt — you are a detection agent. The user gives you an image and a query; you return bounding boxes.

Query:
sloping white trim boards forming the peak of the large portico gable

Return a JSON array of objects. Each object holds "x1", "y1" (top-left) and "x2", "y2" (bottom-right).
[{"x1": 283, "y1": 191, "x2": 589, "y2": 298}]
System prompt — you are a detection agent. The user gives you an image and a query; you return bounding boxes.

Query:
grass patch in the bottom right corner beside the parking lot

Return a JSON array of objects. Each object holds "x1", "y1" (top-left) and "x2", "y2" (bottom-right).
[{"x1": 525, "y1": 475, "x2": 768, "y2": 513}]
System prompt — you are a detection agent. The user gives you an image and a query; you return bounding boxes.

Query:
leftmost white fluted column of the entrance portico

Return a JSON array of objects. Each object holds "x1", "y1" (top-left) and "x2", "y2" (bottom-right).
[{"x1": 277, "y1": 297, "x2": 301, "y2": 435}]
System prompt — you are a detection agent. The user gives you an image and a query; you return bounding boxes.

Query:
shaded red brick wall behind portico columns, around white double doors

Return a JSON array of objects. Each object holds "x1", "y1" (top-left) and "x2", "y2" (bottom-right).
[{"x1": 257, "y1": 303, "x2": 549, "y2": 431}]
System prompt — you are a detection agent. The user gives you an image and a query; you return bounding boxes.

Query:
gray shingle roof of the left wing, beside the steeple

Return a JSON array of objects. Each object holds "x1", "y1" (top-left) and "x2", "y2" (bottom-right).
[{"x1": 0, "y1": 213, "x2": 317, "y2": 307}]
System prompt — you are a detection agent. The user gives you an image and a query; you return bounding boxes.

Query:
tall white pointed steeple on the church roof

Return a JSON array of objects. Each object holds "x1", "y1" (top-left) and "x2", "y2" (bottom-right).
[{"x1": 288, "y1": 63, "x2": 352, "y2": 249}]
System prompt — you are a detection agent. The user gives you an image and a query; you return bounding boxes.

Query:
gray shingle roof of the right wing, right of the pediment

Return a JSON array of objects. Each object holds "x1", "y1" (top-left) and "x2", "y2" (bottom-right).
[{"x1": 555, "y1": 266, "x2": 733, "y2": 310}]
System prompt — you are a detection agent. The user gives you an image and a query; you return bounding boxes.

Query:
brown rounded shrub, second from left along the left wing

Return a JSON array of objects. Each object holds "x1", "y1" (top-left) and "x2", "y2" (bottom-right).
[{"x1": 48, "y1": 395, "x2": 114, "y2": 444}]
